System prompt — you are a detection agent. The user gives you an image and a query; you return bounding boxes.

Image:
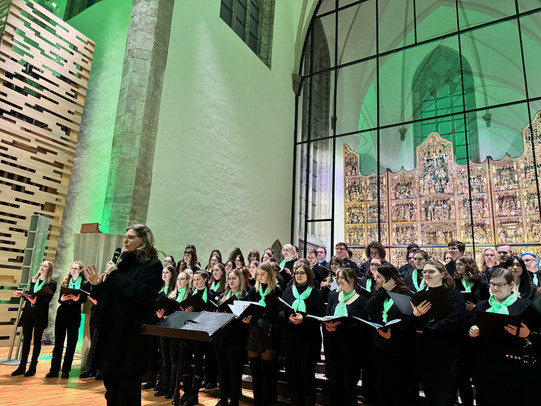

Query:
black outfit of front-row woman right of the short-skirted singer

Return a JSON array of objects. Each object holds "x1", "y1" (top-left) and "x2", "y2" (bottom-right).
[{"x1": 279, "y1": 286, "x2": 325, "y2": 406}]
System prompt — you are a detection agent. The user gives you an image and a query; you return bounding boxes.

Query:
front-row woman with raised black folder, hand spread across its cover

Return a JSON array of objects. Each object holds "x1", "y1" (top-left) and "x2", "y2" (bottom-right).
[{"x1": 412, "y1": 260, "x2": 466, "y2": 406}]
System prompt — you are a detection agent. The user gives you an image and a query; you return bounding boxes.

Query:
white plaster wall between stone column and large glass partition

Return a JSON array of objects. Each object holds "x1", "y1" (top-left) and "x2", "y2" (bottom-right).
[{"x1": 147, "y1": 0, "x2": 301, "y2": 265}]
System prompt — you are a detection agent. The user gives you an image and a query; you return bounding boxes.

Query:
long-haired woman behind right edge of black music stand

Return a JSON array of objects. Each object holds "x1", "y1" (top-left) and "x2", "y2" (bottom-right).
[{"x1": 214, "y1": 269, "x2": 248, "y2": 406}]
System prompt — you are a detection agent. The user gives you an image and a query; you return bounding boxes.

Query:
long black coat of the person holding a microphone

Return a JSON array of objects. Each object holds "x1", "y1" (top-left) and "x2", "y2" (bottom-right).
[{"x1": 95, "y1": 254, "x2": 163, "y2": 375}]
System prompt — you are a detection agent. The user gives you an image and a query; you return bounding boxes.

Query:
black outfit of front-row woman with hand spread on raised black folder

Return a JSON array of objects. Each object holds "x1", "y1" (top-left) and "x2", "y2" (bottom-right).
[{"x1": 412, "y1": 288, "x2": 466, "y2": 406}]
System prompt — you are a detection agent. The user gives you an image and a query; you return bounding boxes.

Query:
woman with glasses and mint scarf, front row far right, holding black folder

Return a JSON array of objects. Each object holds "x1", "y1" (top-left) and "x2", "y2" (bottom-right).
[{"x1": 469, "y1": 268, "x2": 541, "y2": 406}]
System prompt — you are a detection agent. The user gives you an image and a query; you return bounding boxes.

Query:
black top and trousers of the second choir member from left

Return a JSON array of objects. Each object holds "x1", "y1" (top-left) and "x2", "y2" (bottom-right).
[{"x1": 50, "y1": 280, "x2": 91, "y2": 375}]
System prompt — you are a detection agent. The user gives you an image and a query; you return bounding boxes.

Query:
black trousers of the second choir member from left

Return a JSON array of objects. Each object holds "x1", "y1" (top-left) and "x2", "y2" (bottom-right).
[{"x1": 51, "y1": 313, "x2": 81, "y2": 373}]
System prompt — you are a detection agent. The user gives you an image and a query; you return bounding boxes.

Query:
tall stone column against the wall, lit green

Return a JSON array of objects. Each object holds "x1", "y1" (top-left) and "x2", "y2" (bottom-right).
[{"x1": 103, "y1": 0, "x2": 174, "y2": 234}]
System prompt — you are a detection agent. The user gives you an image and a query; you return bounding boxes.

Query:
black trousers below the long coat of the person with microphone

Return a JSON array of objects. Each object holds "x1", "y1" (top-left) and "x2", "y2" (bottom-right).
[{"x1": 103, "y1": 373, "x2": 141, "y2": 406}]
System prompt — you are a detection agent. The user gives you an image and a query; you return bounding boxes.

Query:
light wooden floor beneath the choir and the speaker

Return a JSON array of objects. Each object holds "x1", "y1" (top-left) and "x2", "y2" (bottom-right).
[{"x1": 0, "y1": 346, "x2": 287, "y2": 406}]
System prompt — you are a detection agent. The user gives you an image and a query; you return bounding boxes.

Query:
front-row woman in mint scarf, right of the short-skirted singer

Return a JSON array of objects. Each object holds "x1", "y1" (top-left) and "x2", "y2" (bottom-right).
[{"x1": 279, "y1": 261, "x2": 325, "y2": 406}]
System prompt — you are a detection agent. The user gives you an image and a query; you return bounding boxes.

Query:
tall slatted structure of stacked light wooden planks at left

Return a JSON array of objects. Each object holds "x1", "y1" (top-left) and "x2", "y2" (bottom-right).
[{"x1": 0, "y1": 0, "x2": 94, "y2": 345}]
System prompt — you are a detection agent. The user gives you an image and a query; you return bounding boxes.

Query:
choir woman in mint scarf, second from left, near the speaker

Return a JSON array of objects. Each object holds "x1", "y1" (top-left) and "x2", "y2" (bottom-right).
[{"x1": 46, "y1": 261, "x2": 90, "y2": 378}]
